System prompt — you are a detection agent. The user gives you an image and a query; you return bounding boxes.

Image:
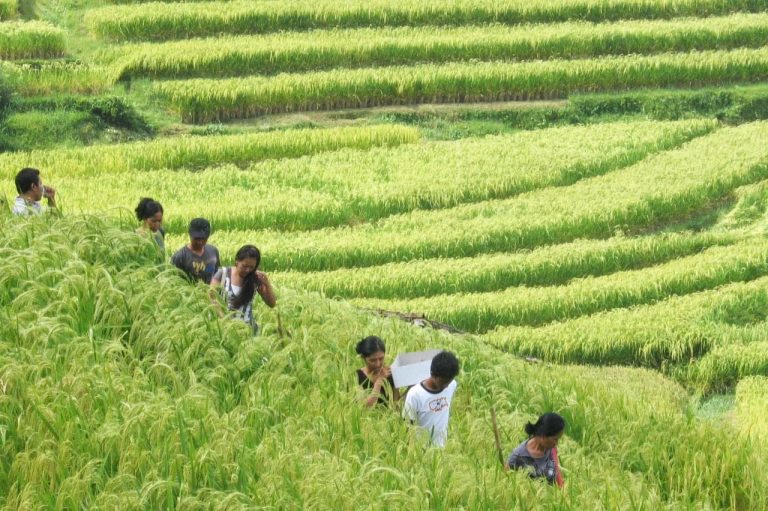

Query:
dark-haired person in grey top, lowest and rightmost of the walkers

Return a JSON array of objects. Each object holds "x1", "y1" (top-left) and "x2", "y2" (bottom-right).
[{"x1": 506, "y1": 412, "x2": 565, "y2": 488}]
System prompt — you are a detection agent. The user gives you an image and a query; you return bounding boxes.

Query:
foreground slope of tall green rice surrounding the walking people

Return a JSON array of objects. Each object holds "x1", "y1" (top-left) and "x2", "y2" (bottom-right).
[{"x1": 0, "y1": 217, "x2": 768, "y2": 510}]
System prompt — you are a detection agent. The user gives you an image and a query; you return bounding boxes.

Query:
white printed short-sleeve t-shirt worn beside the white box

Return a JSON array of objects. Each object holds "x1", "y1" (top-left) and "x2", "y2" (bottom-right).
[{"x1": 403, "y1": 380, "x2": 457, "y2": 447}]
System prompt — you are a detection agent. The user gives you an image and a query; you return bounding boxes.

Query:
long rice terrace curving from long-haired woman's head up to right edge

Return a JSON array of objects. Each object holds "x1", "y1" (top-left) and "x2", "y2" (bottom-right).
[{"x1": 194, "y1": 123, "x2": 768, "y2": 271}]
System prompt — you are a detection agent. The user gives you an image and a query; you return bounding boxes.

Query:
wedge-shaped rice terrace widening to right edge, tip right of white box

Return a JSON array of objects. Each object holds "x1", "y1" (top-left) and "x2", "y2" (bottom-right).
[{"x1": 484, "y1": 277, "x2": 768, "y2": 380}]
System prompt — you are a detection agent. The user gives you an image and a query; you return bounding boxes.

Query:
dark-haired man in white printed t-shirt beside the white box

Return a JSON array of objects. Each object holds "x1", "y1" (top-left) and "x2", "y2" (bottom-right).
[{"x1": 403, "y1": 351, "x2": 459, "y2": 447}]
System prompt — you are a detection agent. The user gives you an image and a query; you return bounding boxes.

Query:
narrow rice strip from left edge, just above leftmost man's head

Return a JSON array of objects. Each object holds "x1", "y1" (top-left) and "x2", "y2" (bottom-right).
[{"x1": 0, "y1": 125, "x2": 420, "y2": 183}]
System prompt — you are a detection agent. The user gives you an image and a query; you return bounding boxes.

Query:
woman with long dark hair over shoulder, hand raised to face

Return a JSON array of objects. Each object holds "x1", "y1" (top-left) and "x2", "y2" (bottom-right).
[{"x1": 211, "y1": 245, "x2": 277, "y2": 333}]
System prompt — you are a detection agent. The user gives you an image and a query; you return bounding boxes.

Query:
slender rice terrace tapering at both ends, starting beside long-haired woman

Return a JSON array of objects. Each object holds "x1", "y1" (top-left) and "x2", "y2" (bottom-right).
[{"x1": 271, "y1": 233, "x2": 737, "y2": 305}]
